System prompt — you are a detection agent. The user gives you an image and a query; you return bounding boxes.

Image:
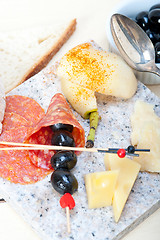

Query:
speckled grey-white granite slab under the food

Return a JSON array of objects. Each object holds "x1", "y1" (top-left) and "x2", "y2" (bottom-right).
[{"x1": 0, "y1": 64, "x2": 160, "y2": 240}]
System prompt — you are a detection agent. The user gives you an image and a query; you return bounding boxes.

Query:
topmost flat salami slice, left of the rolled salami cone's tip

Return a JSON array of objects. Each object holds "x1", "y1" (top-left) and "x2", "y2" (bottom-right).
[{"x1": 5, "y1": 95, "x2": 45, "y2": 126}]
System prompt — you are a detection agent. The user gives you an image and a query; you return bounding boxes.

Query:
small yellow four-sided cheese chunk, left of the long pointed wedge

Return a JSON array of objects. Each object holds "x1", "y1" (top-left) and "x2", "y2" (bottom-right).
[{"x1": 85, "y1": 171, "x2": 119, "y2": 208}]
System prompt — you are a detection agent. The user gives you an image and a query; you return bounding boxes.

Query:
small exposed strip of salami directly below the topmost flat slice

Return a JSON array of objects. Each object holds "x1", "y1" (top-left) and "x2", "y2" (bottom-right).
[{"x1": 2, "y1": 112, "x2": 30, "y2": 132}]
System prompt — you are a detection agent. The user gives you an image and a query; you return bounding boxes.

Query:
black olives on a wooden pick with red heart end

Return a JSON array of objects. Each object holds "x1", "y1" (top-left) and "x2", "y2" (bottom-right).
[{"x1": 51, "y1": 123, "x2": 78, "y2": 233}]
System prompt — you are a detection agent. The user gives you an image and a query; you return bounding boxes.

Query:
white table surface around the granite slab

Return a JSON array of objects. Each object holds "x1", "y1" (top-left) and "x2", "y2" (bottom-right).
[{"x1": 0, "y1": 0, "x2": 160, "y2": 240}]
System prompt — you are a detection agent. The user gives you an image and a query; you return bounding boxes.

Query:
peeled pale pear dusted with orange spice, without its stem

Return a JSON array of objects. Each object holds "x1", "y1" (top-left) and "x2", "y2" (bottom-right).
[{"x1": 57, "y1": 43, "x2": 137, "y2": 117}]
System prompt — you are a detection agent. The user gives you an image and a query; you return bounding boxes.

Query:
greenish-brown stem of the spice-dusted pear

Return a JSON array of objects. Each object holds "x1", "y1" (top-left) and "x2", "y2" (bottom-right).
[{"x1": 86, "y1": 111, "x2": 99, "y2": 148}]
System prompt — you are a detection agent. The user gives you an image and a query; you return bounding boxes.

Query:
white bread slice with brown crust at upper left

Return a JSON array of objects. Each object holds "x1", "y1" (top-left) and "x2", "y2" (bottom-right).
[{"x1": 0, "y1": 19, "x2": 76, "y2": 93}]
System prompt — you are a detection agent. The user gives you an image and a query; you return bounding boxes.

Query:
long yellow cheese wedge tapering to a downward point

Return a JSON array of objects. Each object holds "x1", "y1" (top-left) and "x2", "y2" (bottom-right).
[{"x1": 104, "y1": 153, "x2": 141, "y2": 222}]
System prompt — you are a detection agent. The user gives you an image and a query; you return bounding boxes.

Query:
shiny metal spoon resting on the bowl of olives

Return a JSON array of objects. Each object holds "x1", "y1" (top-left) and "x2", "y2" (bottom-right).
[{"x1": 111, "y1": 14, "x2": 160, "y2": 84}]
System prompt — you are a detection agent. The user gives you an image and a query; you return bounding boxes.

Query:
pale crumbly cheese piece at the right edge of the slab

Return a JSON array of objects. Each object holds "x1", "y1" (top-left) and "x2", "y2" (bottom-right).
[{"x1": 131, "y1": 101, "x2": 160, "y2": 172}]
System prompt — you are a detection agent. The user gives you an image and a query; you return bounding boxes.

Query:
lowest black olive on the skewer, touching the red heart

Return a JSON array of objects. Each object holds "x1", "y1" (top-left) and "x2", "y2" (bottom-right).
[{"x1": 51, "y1": 169, "x2": 78, "y2": 194}]
